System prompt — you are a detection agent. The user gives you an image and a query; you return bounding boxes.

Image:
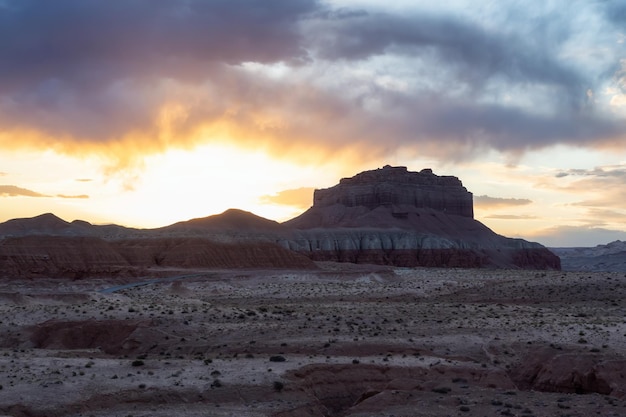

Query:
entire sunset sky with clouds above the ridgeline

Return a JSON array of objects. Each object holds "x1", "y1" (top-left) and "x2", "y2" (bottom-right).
[{"x1": 0, "y1": 0, "x2": 626, "y2": 246}]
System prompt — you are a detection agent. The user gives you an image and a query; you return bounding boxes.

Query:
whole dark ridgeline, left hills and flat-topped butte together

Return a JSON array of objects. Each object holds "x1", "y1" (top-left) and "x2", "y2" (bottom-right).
[{"x1": 0, "y1": 166, "x2": 560, "y2": 278}]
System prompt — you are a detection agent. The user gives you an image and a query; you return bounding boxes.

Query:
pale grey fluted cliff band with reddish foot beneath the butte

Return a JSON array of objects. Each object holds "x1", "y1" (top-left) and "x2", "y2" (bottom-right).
[{"x1": 278, "y1": 228, "x2": 560, "y2": 269}]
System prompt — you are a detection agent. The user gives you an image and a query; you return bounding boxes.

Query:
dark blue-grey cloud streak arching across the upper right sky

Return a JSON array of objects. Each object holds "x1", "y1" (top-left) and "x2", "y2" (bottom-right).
[{"x1": 312, "y1": 13, "x2": 587, "y2": 100}]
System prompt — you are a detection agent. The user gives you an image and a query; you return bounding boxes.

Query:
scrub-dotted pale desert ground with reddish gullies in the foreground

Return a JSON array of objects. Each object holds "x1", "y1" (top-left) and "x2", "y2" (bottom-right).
[{"x1": 0, "y1": 263, "x2": 626, "y2": 417}]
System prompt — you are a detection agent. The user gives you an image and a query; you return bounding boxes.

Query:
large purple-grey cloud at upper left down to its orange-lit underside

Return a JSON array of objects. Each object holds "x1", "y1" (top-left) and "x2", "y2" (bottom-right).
[{"x1": 0, "y1": 0, "x2": 317, "y2": 141}]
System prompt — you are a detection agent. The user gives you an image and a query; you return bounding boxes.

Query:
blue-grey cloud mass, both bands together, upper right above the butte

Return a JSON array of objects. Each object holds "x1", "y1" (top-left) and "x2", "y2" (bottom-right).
[{"x1": 300, "y1": 6, "x2": 626, "y2": 156}]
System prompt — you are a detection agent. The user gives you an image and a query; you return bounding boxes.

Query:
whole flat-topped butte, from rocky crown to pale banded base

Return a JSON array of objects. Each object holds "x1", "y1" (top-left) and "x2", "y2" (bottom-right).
[{"x1": 279, "y1": 166, "x2": 560, "y2": 269}]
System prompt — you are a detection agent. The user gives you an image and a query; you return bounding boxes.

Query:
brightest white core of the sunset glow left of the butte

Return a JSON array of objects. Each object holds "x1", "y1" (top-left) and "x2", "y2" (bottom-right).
[{"x1": 120, "y1": 145, "x2": 312, "y2": 225}]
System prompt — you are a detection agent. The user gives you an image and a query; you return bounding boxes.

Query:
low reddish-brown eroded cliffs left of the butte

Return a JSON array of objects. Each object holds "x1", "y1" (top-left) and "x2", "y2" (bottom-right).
[{"x1": 0, "y1": 232, "x2": 315, "y2": 279}]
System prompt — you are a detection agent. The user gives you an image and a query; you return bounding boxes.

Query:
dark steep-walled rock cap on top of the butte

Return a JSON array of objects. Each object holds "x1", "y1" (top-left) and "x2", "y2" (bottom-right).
[{"x1": 313, "y1": 165, "x2": 474, "y2": 218}]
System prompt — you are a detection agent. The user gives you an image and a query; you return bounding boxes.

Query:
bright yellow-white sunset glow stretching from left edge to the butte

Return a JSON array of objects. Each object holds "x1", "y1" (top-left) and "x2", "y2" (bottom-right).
[{"x1": 0, "y1": 144, "x2": 346, "y2": 228}]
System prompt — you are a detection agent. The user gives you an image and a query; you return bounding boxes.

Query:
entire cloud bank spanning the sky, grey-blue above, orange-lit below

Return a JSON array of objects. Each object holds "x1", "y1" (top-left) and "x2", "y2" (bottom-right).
[{"x1": 0, "y1": 0, "x2": 626, "y2": 168}]
